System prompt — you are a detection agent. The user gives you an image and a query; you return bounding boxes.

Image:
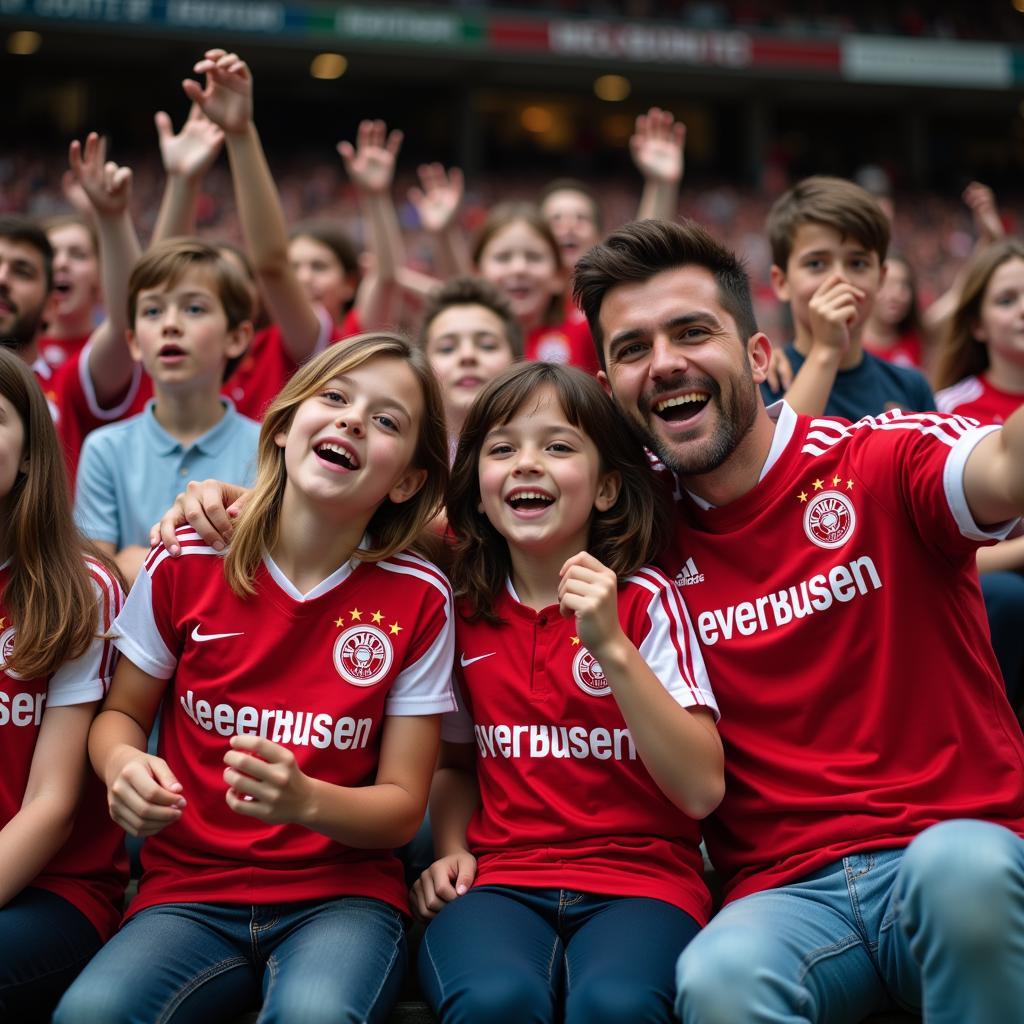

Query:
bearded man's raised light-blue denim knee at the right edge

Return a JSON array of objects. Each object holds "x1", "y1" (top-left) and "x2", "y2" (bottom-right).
[{"x1": 879, "y1": 820, "x2": 1024, "y2": 1024}]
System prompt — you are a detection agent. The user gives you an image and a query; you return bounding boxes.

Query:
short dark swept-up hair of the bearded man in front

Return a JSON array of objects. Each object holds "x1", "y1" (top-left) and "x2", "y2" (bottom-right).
[{"x1": 572, "y1": 220, "x2": 758, "y2": 370}]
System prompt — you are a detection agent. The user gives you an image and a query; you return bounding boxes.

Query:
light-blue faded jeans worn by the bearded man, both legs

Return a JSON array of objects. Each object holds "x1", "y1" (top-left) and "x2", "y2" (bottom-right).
[{"x1": 676, "y1": 819, "x2": 1024, "y2": 1024}]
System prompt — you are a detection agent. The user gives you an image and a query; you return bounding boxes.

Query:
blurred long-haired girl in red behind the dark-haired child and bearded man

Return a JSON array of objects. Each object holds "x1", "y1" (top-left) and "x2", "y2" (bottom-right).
[{"x1": 473, "y1": 203, "x2": 598, "y2": 374}]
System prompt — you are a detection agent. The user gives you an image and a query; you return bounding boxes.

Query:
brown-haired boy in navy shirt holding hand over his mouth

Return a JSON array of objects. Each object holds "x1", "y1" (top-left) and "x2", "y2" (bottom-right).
[{"x1": 762, "y1": 177, "x2": 935, "y2": 420}]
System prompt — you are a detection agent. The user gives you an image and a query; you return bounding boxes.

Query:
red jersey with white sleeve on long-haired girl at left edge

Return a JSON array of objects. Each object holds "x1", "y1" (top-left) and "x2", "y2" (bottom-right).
[{"x1": 0, "y1": 559, "x2": 128, "y2": 940}]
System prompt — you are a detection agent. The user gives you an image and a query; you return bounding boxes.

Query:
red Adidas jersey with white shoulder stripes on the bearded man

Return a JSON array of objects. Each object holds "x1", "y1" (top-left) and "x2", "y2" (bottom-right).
[{"x1": 664, "y1": 402, "x2": 1024, "y2": 899}]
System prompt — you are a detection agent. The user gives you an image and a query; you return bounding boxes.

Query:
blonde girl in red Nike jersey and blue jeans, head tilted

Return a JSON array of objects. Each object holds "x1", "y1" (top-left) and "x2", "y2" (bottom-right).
[{"x1": 55, "y1": 335, "x2": 454, "y2": 1024}]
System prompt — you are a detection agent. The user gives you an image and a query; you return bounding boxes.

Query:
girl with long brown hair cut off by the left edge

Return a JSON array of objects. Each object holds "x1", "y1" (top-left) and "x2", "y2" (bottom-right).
[{"x1": 0, "y1": 348, "x2": 126, "y2": 1021}]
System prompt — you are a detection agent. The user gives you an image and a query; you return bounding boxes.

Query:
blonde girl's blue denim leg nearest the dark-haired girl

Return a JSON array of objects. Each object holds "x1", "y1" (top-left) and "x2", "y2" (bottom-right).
[{"x1": 254, "y1": 896, "x2": 407, "y2": 1024}]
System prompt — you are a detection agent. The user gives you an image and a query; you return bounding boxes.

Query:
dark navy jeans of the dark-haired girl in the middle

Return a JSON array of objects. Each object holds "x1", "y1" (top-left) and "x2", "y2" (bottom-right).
[{"x1": 419, "y1": 886, "x2": 699, "y2": 1024}]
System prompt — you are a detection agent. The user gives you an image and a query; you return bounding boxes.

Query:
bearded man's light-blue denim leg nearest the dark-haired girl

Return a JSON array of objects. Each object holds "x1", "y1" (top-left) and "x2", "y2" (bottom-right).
[{"x1": 676, "y1": 853, "x2": 895, "y2": 1024}]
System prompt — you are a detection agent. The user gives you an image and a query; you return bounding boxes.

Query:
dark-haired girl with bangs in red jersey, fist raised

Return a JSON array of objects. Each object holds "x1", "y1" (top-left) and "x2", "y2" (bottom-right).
[{"x1": 413, "y1": 364, "x2": 724, "y2": 1024}]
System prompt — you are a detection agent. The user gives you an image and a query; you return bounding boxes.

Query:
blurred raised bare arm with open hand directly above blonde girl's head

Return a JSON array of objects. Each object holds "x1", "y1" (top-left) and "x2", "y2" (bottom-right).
[{"x1": 338, "y1": 121, "x2": 406, "y2": 331}]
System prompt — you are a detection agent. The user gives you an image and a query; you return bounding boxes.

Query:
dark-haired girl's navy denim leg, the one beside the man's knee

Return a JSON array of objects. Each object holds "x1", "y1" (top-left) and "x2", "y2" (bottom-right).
[{"x1": 563, "y1": 893, "x2": 700, "y2": 1024}]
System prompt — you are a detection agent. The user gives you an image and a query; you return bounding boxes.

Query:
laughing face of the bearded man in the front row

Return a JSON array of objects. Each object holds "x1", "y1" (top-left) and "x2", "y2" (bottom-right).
[{"x1": 600, "y1": 266, "x2": 770, "y2": 476}]
